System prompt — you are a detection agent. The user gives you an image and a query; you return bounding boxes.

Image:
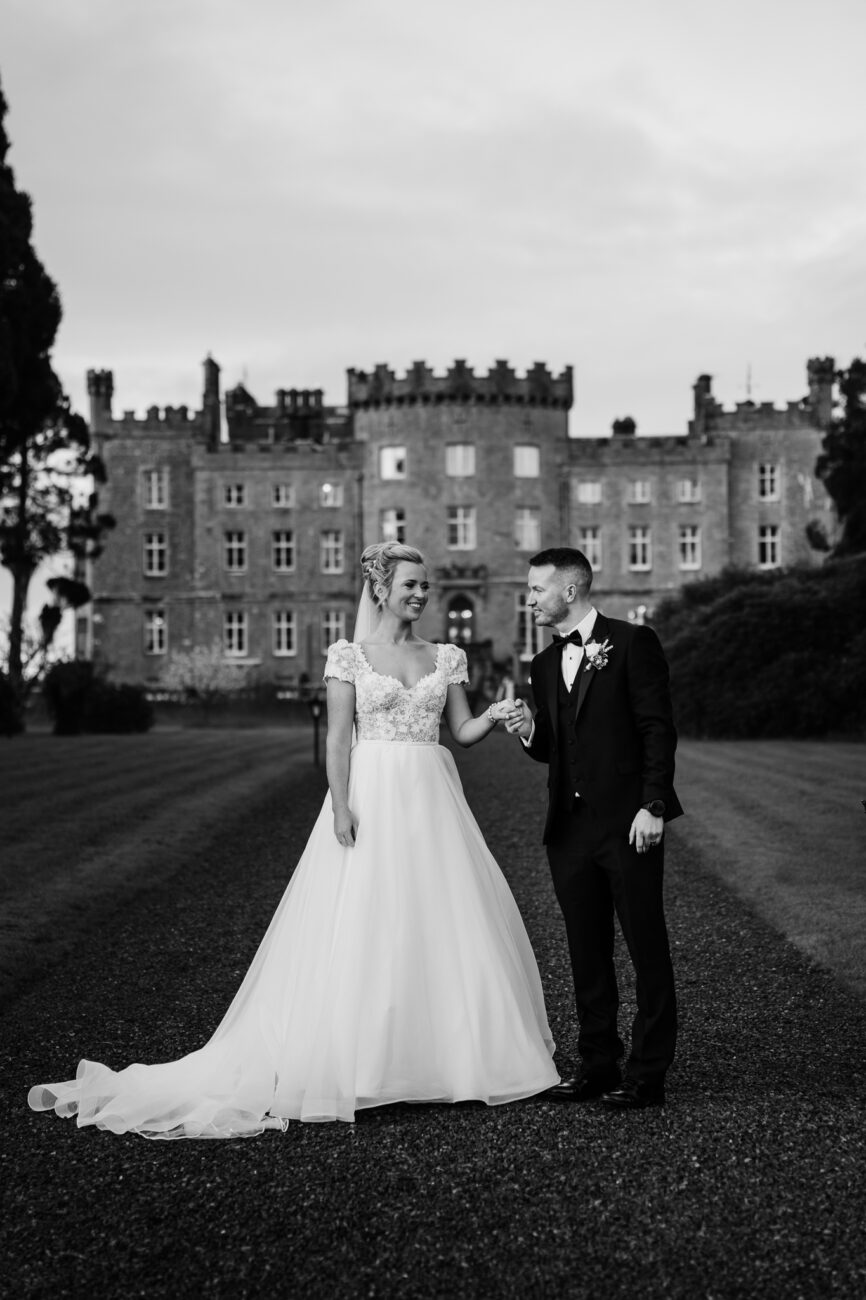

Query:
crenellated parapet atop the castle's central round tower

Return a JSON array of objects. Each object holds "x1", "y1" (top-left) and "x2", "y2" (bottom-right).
[{"x1": 347, "y1": 360, "x2": 575, "y2": 411}]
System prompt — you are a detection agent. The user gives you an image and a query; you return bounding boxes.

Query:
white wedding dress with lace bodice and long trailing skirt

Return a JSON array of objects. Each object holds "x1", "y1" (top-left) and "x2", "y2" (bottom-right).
[{"x1": 29, "y1": 641, "x2": 558, "y2": 1138}]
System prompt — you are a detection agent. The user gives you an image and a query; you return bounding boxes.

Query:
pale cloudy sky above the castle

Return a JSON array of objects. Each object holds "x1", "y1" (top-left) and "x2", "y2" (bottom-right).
[{"x1": 0, "y1": 0, "x2": 866, "y2": 436}]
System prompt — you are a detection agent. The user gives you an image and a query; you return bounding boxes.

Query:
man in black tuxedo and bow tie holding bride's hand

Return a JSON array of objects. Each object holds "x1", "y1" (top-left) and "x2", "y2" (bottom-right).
[{"x1": 507, "y1": 546, "x2": 683, "y2": 1110}]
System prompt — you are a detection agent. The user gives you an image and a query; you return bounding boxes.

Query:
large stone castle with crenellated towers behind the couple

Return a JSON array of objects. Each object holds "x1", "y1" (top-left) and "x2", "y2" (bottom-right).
[{"x1": 77, "y1": 358, "x2": 833, "y2": 685}]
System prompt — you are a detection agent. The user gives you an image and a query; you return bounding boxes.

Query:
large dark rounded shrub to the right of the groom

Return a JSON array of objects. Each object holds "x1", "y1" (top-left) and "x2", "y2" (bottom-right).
[{"x1": 654, "y1": 556, "x2": 866, "y2": 737}]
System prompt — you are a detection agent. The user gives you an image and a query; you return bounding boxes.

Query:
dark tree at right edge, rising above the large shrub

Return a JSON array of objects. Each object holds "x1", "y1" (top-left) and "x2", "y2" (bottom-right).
[{"x1": 815, "y1": 358, "x2": 866, "y2": 555}]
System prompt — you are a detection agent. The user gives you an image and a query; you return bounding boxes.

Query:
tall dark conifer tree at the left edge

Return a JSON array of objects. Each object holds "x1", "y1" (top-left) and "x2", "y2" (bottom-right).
[{"x1": 0, "y1": 76, "x2": 114, "y2": 728}]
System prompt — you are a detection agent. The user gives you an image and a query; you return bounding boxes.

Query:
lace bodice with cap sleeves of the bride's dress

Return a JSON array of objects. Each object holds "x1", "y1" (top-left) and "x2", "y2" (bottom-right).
[{"x1": 319, "y1": 641, "x2": 469, "y2": 745}]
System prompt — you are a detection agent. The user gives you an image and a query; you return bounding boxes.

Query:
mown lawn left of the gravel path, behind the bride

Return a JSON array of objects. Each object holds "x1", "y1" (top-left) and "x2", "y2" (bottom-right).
[{"x1": 0, "y1": 728, "x2": 324, "y2": 997}]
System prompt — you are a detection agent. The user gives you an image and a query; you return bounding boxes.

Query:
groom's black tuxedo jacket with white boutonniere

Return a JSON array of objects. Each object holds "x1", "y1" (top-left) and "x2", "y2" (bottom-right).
[{"x1": 528, "y1": 614, "x2": 683, "y2": 842}]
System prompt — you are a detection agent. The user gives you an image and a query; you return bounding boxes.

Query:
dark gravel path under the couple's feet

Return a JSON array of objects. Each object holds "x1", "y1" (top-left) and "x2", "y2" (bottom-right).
[{"x1": 0, "y1": 736, "x2": 866, "y2": 1300}]
